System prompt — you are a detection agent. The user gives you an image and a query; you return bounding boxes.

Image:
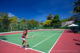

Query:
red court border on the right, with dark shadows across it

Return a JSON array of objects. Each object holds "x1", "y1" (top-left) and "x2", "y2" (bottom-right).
[{"x1": 50, "y1": 30, "x2": 80, "y2": 53}]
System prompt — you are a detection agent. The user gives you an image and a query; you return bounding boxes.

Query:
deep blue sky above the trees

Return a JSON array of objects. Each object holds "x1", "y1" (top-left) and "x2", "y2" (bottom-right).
[{"x1": 0, "y1": 0, "x2": 75, "y2": 21}]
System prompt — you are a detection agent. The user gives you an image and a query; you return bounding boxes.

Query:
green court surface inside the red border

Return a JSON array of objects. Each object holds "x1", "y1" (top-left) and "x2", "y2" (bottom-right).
[{"x1": 0, "y1": 30, "x2": 63, "y2": 53}]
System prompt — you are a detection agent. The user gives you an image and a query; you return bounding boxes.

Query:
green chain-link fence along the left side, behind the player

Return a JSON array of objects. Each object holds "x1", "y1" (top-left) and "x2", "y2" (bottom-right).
[{"x1": 0, "y1": 23, "x2": 39, "y2": 32}]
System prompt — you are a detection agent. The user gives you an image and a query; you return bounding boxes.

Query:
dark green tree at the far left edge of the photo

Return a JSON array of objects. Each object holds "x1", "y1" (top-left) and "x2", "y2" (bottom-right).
[{"x1": 0, "y1": 12, "x2": 10, "y2": 31}]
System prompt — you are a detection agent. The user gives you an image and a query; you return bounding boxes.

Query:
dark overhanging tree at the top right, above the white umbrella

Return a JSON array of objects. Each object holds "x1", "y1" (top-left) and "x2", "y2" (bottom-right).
[{"x1": 73, "y1": 0, "x2": 80, "y2": 30}]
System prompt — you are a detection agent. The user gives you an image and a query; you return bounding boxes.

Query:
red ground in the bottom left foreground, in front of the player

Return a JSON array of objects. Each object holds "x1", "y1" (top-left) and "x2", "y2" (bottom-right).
[{"x1": 0, "y1": 40, "x2": 41, "y2": 53}]
